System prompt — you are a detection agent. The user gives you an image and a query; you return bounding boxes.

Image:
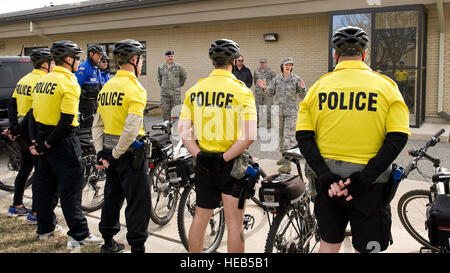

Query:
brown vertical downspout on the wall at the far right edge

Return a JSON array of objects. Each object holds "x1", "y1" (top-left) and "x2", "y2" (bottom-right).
[{"x1": 436, "y1": 0, "x2": 450, "y2": 121}]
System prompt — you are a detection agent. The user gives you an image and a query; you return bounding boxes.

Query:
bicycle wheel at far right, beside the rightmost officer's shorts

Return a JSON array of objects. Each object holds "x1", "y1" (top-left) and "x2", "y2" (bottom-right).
[{"x1": 397, "y1": 190, "x2": 438, "y2": 251}]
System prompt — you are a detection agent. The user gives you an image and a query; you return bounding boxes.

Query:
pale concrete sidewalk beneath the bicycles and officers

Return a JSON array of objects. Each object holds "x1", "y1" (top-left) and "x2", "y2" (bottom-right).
[{"x1": 0, "y1": 159, "x2": 428, "y2": 253}]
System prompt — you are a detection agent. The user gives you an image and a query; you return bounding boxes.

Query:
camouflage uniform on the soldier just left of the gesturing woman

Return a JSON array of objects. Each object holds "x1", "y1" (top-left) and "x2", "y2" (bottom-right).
[{"x1": 254, "y1": 67, "x2": 276, "y2": 128}]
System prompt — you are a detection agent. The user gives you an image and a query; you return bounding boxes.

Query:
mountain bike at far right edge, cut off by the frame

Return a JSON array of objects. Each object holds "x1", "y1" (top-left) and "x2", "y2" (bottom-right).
[{"x1": 397, "y1": 129, "x2": 450, "y2": 252}]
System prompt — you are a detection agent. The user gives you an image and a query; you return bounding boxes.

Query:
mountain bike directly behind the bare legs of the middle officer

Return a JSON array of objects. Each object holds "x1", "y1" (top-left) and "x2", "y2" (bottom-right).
[{"x1": 177, "y1": 153, "x2": 271, "y2": 253}]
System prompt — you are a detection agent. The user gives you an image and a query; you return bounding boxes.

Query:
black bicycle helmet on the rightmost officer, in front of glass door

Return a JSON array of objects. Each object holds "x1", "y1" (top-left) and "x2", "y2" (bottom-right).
[{"x1": 331, "y1": 26, "x2": 369, "y2": 56}]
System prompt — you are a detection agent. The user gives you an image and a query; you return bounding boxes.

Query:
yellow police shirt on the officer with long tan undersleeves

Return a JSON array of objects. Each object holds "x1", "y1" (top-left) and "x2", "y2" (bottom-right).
[{"x1": 97, "y1": 70, "x2": 147, "y2": 136}]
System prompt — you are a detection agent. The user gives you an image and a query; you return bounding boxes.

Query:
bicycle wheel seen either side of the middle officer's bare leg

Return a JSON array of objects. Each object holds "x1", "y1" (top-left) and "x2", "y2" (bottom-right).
[{"x1": 177, "y1": 182, "x2": 225, "y2": 253}]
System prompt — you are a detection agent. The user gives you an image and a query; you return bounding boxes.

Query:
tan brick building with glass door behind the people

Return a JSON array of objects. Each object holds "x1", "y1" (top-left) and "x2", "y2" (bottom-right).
[{"x1": 0, "y1": 0, "x2": 450, "y2": 127}]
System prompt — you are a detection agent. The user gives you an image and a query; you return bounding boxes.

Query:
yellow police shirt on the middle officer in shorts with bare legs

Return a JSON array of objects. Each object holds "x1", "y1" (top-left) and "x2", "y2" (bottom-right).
[{"x1": 180, "y1": 69, "x2": 256, "y2": 152}]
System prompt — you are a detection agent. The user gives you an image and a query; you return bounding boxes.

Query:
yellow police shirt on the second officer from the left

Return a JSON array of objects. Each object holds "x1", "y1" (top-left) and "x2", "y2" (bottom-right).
[{"x1": 32, "y1": 66, "x2": 81, "y2": 127}]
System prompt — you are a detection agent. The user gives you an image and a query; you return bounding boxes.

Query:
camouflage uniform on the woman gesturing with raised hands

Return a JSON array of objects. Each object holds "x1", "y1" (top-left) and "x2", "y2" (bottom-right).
[{"x1": 267, "y1": 73, "x2": 306, "y2": 152}]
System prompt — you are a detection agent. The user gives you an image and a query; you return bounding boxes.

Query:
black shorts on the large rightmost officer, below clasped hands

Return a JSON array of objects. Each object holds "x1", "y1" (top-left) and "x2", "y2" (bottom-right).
[{"x1": 314, "y1": 184, "x2": 392, "y2": 253}]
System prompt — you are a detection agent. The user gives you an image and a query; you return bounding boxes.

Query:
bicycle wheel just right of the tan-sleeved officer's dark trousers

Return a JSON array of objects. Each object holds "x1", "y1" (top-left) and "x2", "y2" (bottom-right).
[{"x1": 149, "y1": 161, "x2": 179, "y2": 226}]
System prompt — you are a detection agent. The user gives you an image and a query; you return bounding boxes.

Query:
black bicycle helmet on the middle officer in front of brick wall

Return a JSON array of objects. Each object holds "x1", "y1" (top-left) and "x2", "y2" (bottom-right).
[{"x1": 209, "y1": 39, "x2": 241, "y2": 65}]
